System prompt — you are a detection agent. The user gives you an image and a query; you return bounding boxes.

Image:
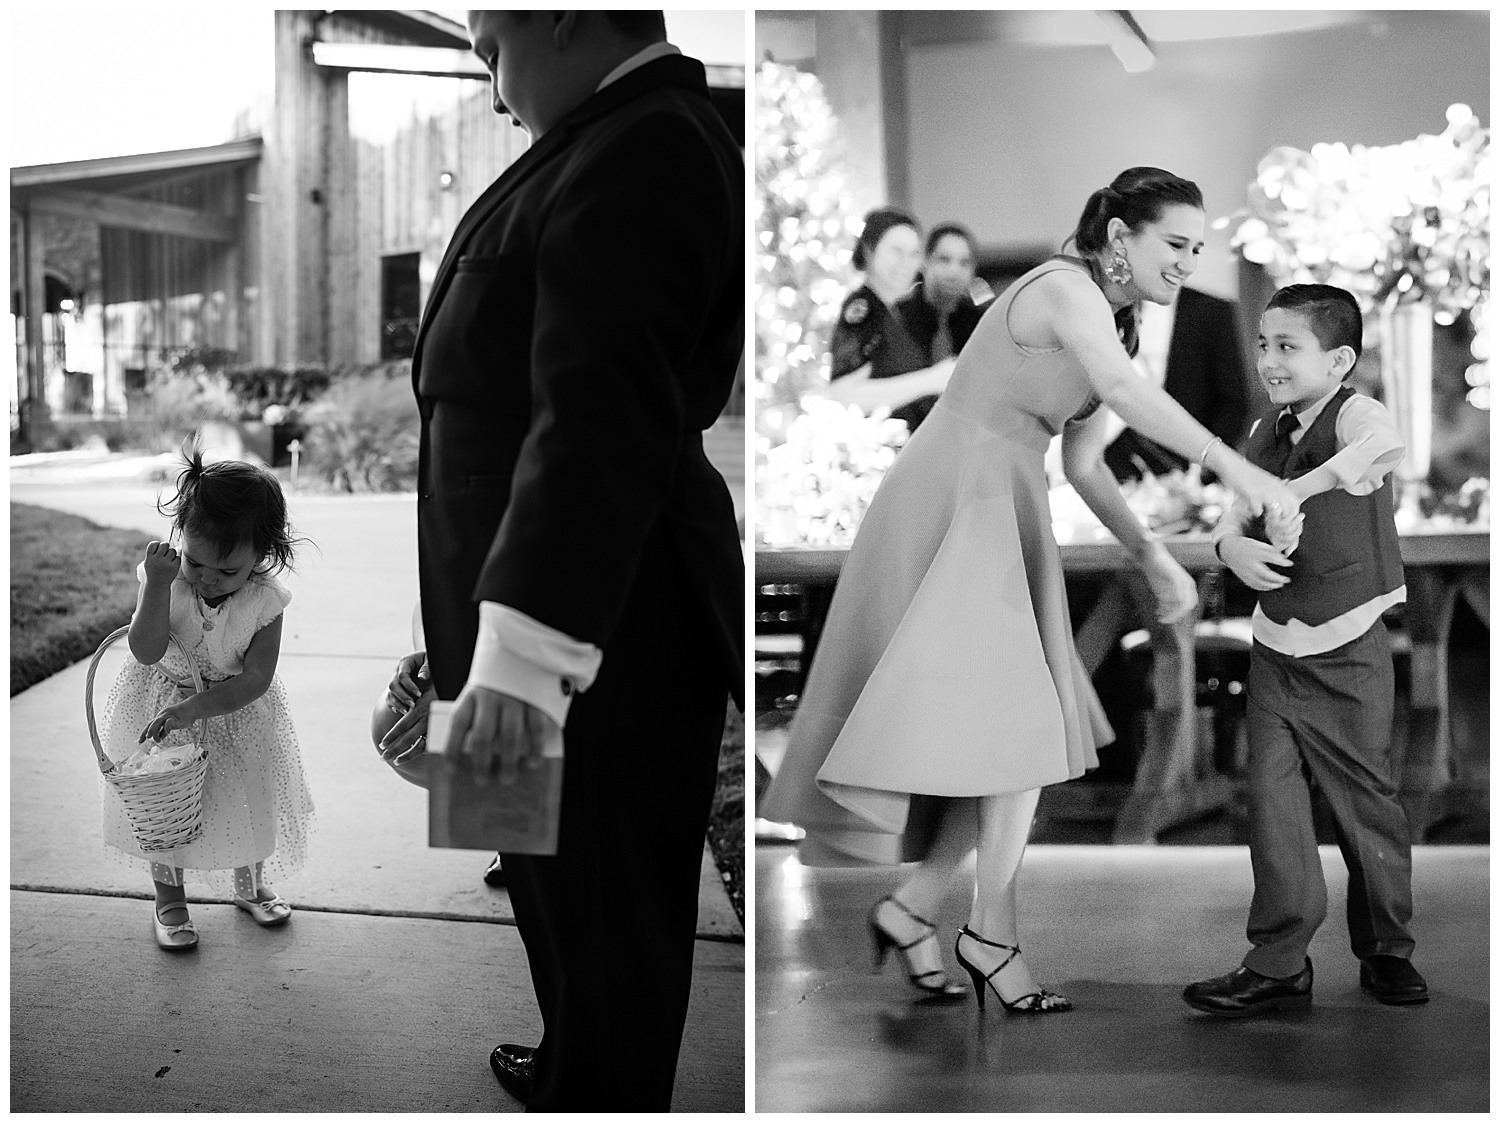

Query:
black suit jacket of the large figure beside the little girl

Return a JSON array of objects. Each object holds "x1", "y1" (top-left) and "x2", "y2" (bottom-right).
[{"x1": 413, "y1": 55, "x2": 746, "y2": 710}]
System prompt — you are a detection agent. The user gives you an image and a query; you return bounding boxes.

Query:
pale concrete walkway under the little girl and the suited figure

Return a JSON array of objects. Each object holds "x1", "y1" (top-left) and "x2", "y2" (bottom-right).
[{"x1": 11, "y1": 457, "x2": 746, "y2": 1111}]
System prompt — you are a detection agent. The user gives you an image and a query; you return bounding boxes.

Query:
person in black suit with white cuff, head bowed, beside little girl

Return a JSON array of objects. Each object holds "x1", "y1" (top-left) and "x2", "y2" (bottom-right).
[{"x1": 413, "y1": 10, "x2": 746, "y2": 1111}]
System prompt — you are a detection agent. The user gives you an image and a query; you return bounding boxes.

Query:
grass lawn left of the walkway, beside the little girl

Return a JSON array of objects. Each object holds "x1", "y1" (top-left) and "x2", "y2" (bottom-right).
[{"x1": 11, "y1": 504, "x2": 150, "y2": 696}]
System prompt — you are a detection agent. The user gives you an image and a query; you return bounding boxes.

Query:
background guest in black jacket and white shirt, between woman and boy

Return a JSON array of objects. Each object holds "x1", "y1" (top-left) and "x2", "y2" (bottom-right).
[{"x1": 1104, "y1": 288, "x2": 1250, "y2": 483}]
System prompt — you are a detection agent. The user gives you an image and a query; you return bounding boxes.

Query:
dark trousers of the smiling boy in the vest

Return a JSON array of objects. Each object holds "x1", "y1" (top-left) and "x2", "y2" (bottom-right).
[{"x1": 1245, "y1": 621, "x2": 1415, "y2": 978}]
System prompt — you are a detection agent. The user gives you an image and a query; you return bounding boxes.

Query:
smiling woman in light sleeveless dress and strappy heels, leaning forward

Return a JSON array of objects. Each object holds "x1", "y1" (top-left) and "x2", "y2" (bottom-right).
[{"x1": 762, "y1": 168, "x2": 1298, "y2": 1014}]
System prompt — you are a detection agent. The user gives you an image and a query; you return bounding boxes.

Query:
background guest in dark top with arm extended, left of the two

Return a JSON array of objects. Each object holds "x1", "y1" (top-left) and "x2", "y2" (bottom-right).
[{"x1": 828, "y1": 207, "x2": 953, "y2": 429}]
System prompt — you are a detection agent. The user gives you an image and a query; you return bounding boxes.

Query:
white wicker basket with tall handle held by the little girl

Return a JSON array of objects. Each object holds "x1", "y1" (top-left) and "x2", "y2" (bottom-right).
[{"x1": 84, "y1": 627, "x2": 209, "y2": 853}]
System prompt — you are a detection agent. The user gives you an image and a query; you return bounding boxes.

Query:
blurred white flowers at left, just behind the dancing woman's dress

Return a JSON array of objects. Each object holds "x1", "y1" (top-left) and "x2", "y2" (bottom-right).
[{"x1": 755, "y1": 397, "x2": 908, "y2": 549}]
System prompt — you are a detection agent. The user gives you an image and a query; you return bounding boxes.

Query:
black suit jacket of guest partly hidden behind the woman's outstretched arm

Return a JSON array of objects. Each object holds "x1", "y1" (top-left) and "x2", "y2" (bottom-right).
[{"x1": 1104, "y1": 288, "x2": 1250, "y2": 480}]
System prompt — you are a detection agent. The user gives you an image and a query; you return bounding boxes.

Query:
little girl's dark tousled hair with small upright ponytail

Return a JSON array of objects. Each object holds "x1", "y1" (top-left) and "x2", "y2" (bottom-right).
[{"x1": 156, "y1": 439, "x2": 306, "y2": 574}]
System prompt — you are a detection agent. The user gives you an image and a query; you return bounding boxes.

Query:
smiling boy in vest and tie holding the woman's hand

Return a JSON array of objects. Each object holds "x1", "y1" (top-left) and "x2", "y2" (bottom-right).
[{"x1": 1182, "y1": 285, "x2": 1428, "y2": 1017}]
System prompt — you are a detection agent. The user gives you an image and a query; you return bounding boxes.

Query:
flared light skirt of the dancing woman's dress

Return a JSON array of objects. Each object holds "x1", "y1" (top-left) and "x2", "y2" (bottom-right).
[{"x1": 762, "y1": 399, "x2": 1115, "y2": 864}]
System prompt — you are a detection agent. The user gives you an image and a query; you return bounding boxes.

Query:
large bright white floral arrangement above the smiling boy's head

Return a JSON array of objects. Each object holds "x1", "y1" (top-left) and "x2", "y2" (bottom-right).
[{"x1": 1215, "y1": 105, "x2": 1490, "y2": 324}]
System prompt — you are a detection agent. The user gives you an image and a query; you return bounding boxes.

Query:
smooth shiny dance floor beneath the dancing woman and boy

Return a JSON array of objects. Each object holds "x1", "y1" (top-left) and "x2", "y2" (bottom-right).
[{"x1": 755, "y1": 841, "x2": 1490, "y2": 1113}]
